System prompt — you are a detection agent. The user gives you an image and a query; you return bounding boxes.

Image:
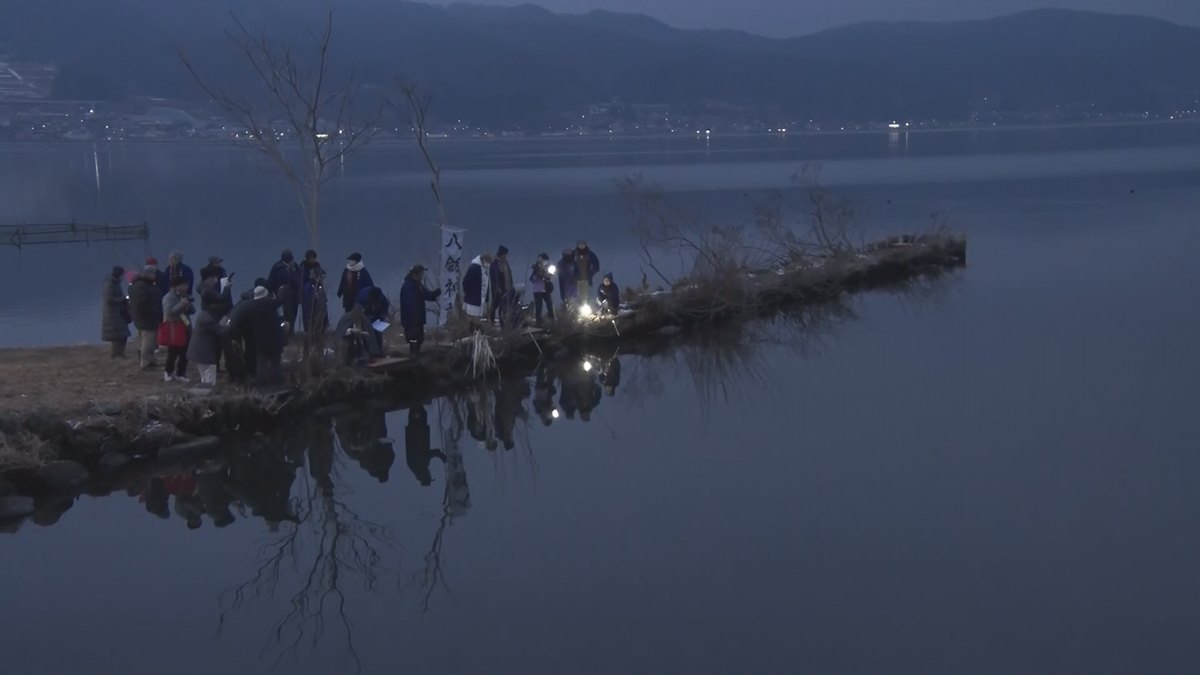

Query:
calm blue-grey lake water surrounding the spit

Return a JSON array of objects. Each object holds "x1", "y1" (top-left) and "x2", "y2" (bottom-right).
[{"x1": 0, "y1": 125, "x2": 1200, "y2": 674}]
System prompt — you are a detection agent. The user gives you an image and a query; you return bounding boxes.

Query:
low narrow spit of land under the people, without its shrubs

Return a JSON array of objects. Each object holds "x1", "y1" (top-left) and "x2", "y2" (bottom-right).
[{"x1": 0, "y1": 229, "x2": 966, "y2": 484}]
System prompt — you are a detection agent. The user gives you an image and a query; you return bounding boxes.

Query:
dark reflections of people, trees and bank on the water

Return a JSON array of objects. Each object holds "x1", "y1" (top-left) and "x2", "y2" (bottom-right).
[{"x1": 0, "y1": 280, "x2": 947, "y2": 670}]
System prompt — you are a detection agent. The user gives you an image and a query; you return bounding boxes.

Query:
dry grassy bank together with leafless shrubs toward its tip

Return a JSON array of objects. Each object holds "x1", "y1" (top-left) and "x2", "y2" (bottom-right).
[{"x1": 0, "y1": 169, "x2": 967, "y2": 519}]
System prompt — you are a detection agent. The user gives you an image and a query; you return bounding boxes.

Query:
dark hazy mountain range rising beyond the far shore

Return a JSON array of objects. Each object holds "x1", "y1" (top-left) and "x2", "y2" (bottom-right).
[{"x1": 0, "y1": 0, "x2": 1200, "y2": 126}]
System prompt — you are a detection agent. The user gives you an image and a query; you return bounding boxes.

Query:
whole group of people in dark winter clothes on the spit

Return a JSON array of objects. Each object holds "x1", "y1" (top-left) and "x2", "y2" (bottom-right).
[{"x1": 101, "y1": 241, "x2": 620, "y2": 386}]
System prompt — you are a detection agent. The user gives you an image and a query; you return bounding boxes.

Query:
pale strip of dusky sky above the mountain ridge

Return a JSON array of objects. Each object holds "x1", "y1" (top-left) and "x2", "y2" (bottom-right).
[{"x1": 429, "y1": 0, "x2": 1200, "y2": 36}]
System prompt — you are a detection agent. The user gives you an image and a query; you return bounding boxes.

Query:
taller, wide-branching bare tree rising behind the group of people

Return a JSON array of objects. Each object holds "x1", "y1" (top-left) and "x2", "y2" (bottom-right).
[{"x1": 180, "y1": 11, "x2": 382, "y2": 249}]
